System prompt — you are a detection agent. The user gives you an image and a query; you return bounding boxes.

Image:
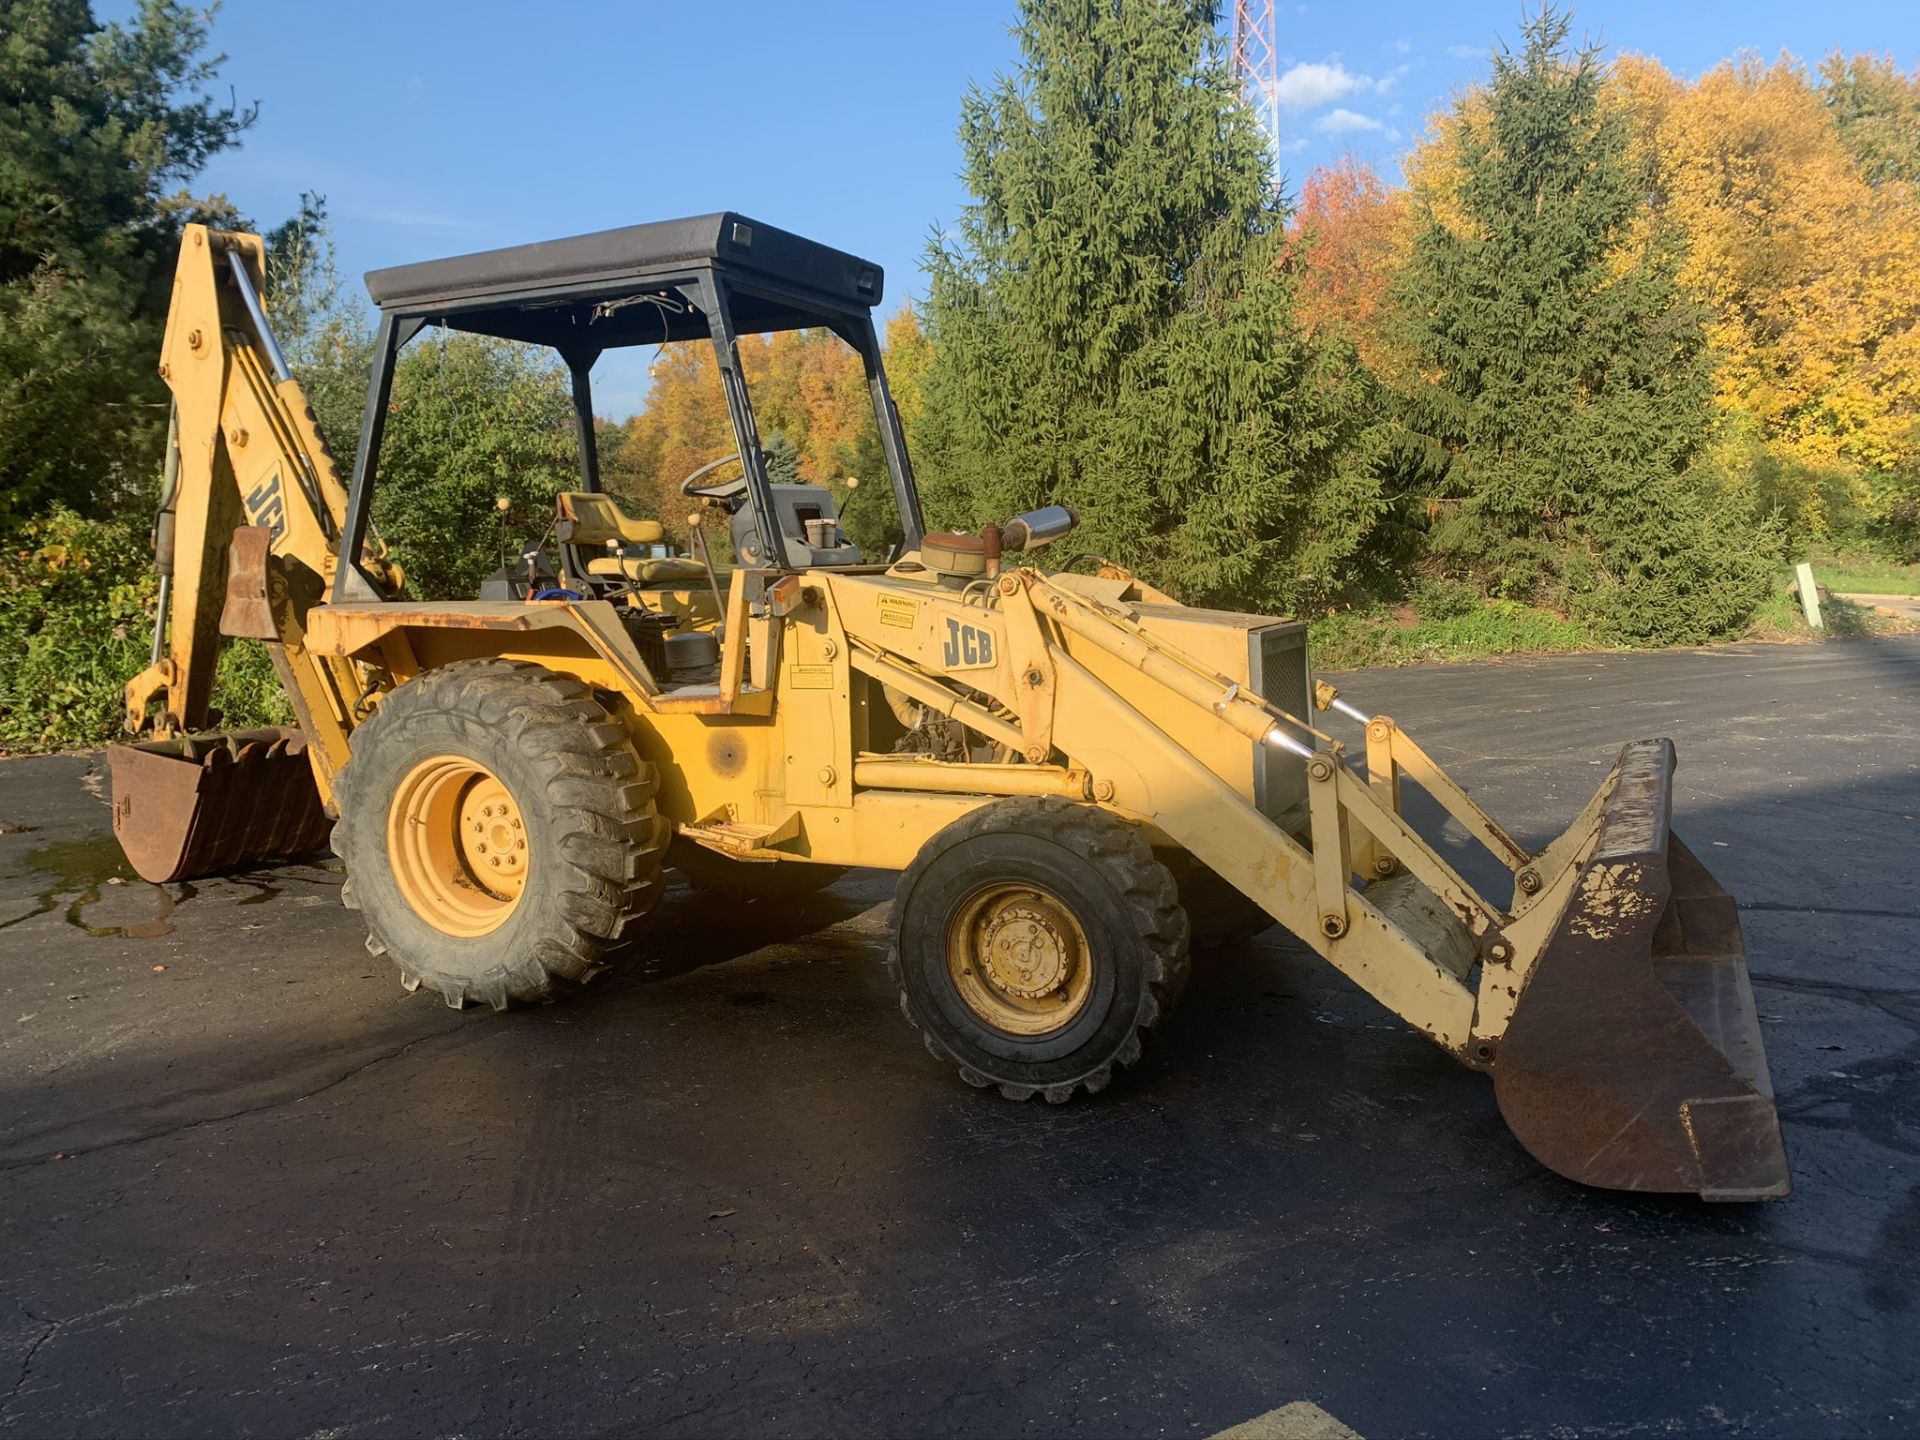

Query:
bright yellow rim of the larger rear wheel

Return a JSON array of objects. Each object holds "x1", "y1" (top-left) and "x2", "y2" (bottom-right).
[{"x1": 386, "y1": 755, "x2": 530, "y2": 937}]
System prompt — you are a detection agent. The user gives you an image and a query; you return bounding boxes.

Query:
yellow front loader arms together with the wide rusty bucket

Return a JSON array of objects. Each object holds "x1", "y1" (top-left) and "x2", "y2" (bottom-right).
[{"x1": 825, "y1": 568, "x2": 1789, "y2": 1200}]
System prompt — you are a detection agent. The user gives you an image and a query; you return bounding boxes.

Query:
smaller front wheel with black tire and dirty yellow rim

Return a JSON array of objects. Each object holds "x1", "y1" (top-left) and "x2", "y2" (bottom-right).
[{"x1": 887, "y1": 799, "x2": 1187, "y2": 1104}]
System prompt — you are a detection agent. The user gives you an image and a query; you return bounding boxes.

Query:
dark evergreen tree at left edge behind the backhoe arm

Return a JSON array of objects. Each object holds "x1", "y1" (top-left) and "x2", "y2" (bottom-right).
[{"x1": 0, "y1": 0, "x2": 253, "y2": 526}]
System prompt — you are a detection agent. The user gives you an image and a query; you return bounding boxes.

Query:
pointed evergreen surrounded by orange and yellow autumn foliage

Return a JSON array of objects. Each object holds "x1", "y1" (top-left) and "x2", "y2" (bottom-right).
[{"x1": 1394, "y1": 8, "x2": 1768, "y2": 641}]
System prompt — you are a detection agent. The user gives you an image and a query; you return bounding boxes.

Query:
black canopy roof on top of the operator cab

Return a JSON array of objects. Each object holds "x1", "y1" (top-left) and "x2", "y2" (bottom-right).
[{"x1": 367, "y1": 211, "x2": 885, "y2": 348}]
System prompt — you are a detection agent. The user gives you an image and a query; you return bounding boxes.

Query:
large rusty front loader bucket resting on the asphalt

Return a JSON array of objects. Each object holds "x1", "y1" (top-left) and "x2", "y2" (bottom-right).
[{"x1": 1494, "y1": 739, "x2": 1791, "y2": 1200}]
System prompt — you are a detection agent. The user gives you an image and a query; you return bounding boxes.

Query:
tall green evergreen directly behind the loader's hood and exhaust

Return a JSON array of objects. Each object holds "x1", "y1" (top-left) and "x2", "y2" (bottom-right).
[{"x1": 916, "y1": 0, "x2": 1380, "y2": 605}]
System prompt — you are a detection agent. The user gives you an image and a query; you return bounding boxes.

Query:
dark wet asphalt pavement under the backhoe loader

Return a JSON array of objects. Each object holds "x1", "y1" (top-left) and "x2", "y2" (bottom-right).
[{"x1": 0, "y1": 637, "x2": 1920, "y2": 1440}]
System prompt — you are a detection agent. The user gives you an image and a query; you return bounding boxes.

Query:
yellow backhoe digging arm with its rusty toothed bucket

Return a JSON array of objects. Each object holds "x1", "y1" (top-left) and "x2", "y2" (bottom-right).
[{"x1": 109, "y1": 225, "x2": 399, "y2": 879}]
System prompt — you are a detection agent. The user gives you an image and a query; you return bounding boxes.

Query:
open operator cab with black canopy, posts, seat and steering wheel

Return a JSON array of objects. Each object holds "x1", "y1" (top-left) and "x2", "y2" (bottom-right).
[{"x1": 332, "y1": 211, "x2": 925, "y2": 603}]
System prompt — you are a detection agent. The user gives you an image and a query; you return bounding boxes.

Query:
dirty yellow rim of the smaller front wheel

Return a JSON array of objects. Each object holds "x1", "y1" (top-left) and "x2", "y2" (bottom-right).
[{"x1": 947, "y1": 885, "x2": 1092, "y2": 1035}]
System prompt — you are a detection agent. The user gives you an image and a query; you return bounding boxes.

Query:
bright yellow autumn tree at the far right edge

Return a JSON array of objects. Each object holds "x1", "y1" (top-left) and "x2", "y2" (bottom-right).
[{"x1": 1613, "y1": 58, "x2": 1920, "y2": 485}]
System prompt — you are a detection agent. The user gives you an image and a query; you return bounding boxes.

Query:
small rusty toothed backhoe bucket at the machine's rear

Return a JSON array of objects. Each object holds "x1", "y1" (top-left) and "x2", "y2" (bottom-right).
[{"x1": 108, "y1": 728, "x2": 332, "y2": 885}]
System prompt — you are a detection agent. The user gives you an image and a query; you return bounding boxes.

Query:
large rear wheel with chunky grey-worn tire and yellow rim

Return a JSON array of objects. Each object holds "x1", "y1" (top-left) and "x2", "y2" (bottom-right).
[{"x1": 334, "y1": 660, "x2": 668, "y2": 1010}]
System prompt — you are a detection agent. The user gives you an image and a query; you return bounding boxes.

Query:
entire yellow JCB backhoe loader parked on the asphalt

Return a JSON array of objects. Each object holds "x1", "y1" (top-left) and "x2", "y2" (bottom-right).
[{"x1": 111, "y1": 213, "x2": 1789, "y2": 1200}]
